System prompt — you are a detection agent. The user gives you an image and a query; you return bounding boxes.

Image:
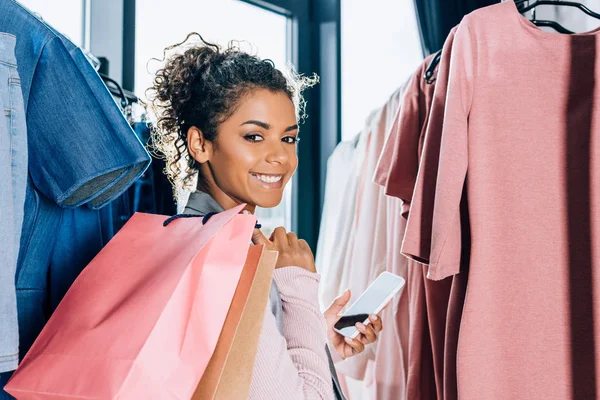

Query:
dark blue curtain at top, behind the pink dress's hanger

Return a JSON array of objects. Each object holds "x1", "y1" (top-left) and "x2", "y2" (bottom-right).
[{"x1": 415, "y1": 0, "x2": 500, "y2": 56}]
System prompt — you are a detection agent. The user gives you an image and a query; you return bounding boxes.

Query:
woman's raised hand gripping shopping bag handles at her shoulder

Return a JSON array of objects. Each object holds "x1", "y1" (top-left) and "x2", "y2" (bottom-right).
[{"x1": 252, "y1": 227, "x2": 317, "y2": 272}]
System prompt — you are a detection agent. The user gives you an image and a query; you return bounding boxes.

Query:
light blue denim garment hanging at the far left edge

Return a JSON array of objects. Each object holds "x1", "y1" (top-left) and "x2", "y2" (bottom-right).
[{"x1": 0, "y1": 33, "x2": 27, "y2": 372}]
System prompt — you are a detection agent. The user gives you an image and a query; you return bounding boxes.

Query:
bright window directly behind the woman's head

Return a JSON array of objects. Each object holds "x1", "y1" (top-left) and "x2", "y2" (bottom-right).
[{"x1": 135, "y1": 0, "x2": 291, "y2": 234}]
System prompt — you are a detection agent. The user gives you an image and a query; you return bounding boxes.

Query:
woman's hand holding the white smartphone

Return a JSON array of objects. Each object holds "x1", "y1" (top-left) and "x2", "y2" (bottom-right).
[{"x1": 324, "y1": 290, "x2": 383, "y2": 359}]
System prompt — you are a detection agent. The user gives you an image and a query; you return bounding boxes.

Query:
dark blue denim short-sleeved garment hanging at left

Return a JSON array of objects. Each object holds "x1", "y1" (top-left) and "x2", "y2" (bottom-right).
[{"x1": 0, "y1": 0, "x2": 150, "y2": 398}]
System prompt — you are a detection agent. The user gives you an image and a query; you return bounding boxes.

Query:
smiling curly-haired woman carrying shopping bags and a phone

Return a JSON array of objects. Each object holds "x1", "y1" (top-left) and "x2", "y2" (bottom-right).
[{"x1": 150, "y1": 34, "x2": 382, "y2": 400}]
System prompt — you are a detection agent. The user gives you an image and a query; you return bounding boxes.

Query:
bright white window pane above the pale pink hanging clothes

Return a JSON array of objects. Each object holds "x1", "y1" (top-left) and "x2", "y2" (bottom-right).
[{"x1": 341, "y1": 0, "x2": 423, "y2": 140}]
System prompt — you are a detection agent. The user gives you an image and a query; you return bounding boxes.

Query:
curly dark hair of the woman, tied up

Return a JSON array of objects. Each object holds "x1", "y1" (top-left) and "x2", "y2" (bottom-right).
[{"x1": 147, "y1": 33, "x2": 318, "y2": 194}]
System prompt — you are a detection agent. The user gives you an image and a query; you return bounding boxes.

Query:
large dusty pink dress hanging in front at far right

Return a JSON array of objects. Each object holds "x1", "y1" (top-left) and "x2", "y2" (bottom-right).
[{"x1": 403, "y1": 1, "x2": 600, "y2": 400}]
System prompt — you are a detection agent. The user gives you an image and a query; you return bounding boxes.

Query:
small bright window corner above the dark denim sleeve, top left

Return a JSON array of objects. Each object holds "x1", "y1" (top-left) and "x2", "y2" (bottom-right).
[{"x1": 18, "y1": 0, "x2": 84, "y2": 46}]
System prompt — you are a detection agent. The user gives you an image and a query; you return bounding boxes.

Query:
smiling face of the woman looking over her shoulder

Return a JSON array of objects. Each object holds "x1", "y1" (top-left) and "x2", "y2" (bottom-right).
[{"x1": 195, "y1": 89, "x2": 298, "y2": 212}]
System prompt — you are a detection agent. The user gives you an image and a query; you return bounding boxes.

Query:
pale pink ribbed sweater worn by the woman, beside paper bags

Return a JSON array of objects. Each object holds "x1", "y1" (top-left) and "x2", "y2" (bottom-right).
[{"x1": 250, "y1": 267, "x2": 334, "y2": 400}]
